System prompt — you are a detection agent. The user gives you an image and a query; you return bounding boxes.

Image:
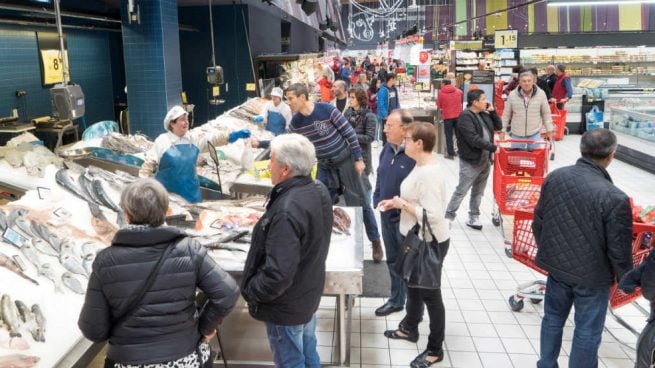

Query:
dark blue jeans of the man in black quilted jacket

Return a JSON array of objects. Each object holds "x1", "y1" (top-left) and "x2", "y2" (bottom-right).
[{"x1": 537, "y1": 276, "x2": 610, "y2": 368}]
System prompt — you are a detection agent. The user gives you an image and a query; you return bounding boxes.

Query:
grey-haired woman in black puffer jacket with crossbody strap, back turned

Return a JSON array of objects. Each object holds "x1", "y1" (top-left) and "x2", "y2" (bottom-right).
[{"x1": 78, "y1": 179, "x2": 239, "y2": 368}]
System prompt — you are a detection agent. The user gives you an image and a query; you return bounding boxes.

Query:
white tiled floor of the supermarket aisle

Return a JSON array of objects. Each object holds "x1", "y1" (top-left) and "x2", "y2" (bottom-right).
[{"x1": 318, "y1": 91, "x2": 655, "y2": 368}]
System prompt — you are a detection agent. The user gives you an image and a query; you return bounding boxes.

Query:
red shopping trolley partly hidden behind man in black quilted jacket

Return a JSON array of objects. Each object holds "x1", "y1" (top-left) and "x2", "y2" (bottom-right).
[{"x1": 509, "y1": 208, "x2": 655, "y2": 335}]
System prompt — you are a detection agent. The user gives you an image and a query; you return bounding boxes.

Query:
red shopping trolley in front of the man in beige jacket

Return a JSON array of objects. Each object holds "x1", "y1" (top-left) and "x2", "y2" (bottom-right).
[{"x1": 491, "y1": 139, "x2": 550, "y2": 257}]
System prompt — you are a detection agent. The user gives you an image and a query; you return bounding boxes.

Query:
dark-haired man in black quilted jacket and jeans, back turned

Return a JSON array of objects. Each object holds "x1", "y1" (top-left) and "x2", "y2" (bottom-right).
[{"x1": 532, "y1": 129, "x2": 632, "y2": 368}]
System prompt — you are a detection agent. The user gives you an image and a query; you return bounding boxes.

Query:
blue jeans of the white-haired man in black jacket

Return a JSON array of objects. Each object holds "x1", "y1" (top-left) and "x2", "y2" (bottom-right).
[{"x1": 266, "y1": 314, "x2": 321, "y2": 368}]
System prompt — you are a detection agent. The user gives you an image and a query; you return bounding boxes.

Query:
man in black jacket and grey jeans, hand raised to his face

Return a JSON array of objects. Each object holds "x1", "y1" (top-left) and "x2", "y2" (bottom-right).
[{"x1": 446, "y1": 89, "x2": 502, "y2": 230}]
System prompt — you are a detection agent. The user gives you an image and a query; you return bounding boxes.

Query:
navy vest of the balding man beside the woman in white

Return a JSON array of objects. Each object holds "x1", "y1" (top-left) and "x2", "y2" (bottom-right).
[{"x1": 373, "y1": 143, "x2": 416, "y2": 223}]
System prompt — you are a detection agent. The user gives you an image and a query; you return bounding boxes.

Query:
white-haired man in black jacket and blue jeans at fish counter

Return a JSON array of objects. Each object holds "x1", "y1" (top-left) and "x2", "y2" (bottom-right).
[{"x1": 241, "y1": 134, "x2": 332, "y2": 367}]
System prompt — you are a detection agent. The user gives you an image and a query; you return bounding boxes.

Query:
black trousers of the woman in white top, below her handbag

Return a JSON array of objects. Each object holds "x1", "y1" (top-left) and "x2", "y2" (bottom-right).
[{"x1": 399, "y1": 287, "x2": 446, "y2": 354}]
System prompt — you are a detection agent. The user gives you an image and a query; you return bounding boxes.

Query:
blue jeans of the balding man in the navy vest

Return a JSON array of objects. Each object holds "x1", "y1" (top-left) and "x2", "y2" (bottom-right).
[{"x1": 381, "y1": 217, "x2": 407, "y2": 307}]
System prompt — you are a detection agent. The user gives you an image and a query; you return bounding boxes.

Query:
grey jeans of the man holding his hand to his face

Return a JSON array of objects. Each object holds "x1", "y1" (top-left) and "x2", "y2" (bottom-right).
[{"x1": 446, "y1": 159, "x2": 491, "y2": 219}]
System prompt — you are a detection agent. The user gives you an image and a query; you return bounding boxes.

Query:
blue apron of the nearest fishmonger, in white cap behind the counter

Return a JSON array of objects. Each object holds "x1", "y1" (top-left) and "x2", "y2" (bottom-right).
[{"x1": 155, "y1": 144, "x2": 202, "y2": 203}]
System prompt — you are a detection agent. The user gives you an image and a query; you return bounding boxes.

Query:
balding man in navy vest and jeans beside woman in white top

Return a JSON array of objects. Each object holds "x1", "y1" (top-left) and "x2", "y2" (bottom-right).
[{"x1": 373, "y1": 110, "x2": 415, "y2": 316}]
